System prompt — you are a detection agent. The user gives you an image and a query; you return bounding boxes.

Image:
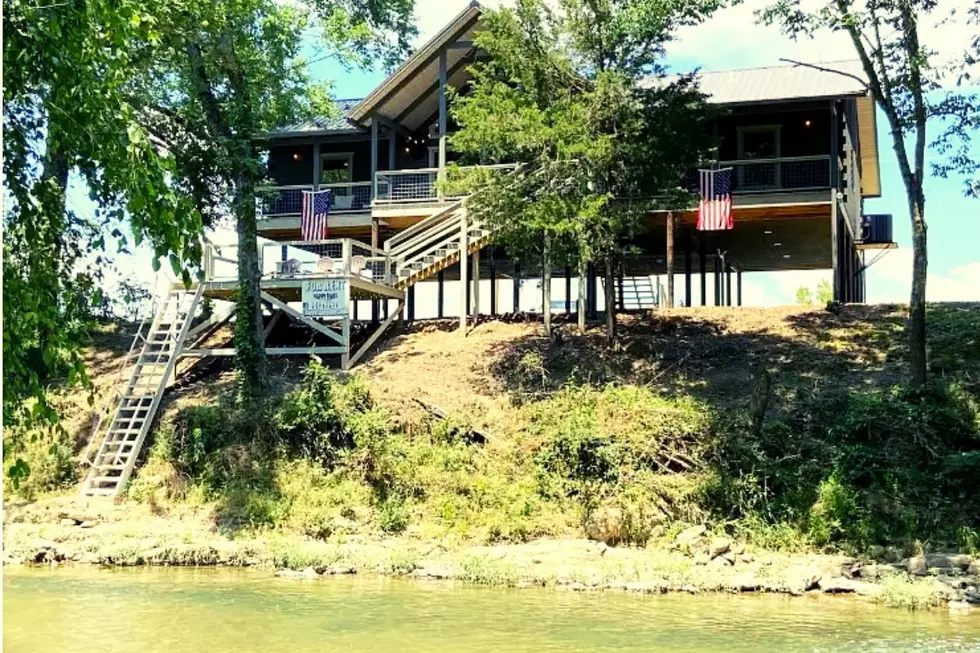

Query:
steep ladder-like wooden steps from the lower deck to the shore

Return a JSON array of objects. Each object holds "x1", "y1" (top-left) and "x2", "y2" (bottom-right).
[{"x1": 82, "y1": 284, "x2": 204, "y2": 497}]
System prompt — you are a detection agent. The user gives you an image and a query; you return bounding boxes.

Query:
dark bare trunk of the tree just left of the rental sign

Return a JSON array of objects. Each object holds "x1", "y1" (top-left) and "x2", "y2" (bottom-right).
[{"x1": 232, "y1": 163, "x2": 269, "y2": 406}]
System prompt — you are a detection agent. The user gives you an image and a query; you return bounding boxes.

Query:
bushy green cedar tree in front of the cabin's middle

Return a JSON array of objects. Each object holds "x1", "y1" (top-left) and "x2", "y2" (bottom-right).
[{"x1": 452, "y1": 0, "x2": 719, "y2": 341}]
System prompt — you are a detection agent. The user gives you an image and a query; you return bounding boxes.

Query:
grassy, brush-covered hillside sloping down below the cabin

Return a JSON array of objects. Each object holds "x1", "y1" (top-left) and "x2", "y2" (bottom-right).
[{"x1": 7, "y1": 305, "x2": 980, "y2": 551}]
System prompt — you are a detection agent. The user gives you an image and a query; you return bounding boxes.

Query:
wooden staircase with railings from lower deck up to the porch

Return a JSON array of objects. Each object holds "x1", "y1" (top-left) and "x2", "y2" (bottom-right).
[{"x1": 385, "y1": 200, "x2": 493, "y2": 290}]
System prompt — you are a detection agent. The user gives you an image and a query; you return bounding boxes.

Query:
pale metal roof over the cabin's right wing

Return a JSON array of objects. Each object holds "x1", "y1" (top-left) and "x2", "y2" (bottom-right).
[{"x1": 668, "y1": 60, "x2": 867, "y2": 105}]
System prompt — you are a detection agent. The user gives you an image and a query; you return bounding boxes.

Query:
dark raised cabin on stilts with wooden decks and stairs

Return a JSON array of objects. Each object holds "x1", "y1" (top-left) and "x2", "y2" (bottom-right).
[{"x1": 83, "y1": 3, "x2": 894, "y2": 496}]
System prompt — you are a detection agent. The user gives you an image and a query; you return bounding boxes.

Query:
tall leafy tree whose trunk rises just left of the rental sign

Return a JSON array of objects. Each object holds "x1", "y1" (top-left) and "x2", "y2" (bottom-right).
[{"x1": 136, "y1": 0, "x2": 412, "y2": 404}]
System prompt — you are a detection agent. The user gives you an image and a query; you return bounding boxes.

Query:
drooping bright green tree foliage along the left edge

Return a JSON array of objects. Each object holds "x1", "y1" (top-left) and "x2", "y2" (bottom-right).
[{"x1": 3, "y1": 0, "x2": 201, "y2": 438}]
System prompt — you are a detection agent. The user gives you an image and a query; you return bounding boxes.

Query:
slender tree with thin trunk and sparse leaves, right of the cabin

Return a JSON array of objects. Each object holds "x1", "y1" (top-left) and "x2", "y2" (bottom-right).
[{"x1": 759, "y1": 0, "x2": 978, "y2": 386}]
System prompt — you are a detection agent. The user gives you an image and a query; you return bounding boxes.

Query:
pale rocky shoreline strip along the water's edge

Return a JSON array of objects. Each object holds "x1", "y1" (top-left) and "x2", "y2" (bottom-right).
[{"x1": 3, "y1": 501, "x2": 980, "y2": 618}]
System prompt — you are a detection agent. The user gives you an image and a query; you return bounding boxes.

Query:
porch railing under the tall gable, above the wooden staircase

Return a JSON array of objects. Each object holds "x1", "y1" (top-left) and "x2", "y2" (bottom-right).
[{"x1": 374, "y1": 163, "x2": 517, "y2": 204}]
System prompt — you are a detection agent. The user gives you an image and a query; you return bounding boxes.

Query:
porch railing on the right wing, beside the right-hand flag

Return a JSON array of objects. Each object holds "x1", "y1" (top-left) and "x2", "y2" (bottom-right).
[{"x1": 718, "y1": 154, "x2": 831, "y2": 193}]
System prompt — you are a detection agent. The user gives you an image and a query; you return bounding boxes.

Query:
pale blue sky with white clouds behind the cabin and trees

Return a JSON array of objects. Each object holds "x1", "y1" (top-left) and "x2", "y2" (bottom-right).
[{"x1": 88, "y1": 0, "x2": 980, "y2": 305}]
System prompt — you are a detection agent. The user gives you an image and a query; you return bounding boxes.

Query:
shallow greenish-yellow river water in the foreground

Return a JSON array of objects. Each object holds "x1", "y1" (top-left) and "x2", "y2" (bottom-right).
[{"x1": 3, "y1": 568, "x2": 980, "y2": 653}]
